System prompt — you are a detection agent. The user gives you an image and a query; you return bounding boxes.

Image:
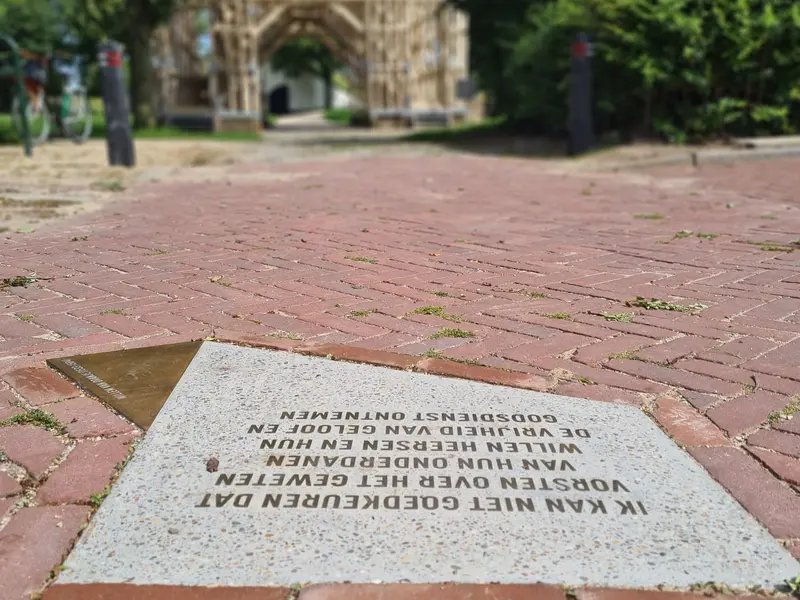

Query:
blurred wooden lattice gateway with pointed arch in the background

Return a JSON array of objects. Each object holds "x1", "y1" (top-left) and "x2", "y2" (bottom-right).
[{"x1": 154, "y1": 0, "x2": 469, "y2": 130}]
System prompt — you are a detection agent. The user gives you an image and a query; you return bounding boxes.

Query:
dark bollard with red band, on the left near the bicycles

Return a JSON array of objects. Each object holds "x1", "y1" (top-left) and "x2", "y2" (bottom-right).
[{"x1": 98, "y1": 41, "x2": 136, "y2": 167}]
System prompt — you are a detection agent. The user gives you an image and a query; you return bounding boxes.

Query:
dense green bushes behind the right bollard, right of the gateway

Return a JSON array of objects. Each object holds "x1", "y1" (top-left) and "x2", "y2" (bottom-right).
[{"x1": 458, "y1": 0, "x2": 800, "y2": 142}]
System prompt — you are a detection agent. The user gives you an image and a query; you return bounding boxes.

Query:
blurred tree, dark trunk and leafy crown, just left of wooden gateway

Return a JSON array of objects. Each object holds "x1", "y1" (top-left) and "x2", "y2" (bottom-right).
[{"x1": 69, "y1": 0, "x2": 180, "y2": 129}]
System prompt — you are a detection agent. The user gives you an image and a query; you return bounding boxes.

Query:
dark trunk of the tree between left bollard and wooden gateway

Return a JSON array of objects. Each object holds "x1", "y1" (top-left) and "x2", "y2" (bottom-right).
[{"x1": 128, "y1": 12, "x2": 156, "y2": 129}]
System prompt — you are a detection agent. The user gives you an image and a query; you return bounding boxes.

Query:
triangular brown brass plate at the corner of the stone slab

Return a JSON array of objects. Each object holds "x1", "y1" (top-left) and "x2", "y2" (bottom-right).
[{"x1": 47, "y1": 342, "x2": 202, "y2": 429}]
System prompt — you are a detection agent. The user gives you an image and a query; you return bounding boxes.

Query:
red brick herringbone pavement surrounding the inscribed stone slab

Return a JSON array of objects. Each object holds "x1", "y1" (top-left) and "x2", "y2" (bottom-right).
[{"x1": 0, "y1": 157, "x2": 800, "y2": 600}]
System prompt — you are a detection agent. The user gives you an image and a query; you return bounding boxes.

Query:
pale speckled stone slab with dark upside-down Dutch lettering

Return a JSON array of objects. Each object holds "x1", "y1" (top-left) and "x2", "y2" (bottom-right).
[{"x1": 59, "y1": 342, "x2": 797, "y2": 587}]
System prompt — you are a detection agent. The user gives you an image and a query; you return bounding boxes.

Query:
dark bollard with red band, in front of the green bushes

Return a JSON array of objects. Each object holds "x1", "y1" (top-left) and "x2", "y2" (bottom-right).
[{"x1": 568, "y1": 33, "x2": 594, "y2": 156}]
